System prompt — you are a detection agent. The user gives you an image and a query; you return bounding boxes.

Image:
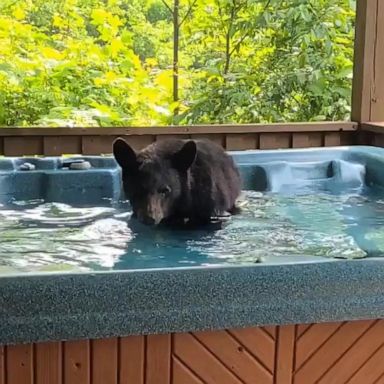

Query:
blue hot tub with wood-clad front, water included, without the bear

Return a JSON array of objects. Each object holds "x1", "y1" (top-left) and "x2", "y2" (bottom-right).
[{"x1": 0, "y1": 146, "x2": 384, "y2": 384}]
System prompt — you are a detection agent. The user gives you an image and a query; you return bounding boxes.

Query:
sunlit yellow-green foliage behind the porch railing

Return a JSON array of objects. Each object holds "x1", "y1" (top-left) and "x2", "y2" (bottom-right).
[{"x1": 0, "y1": 0, "x2": 354, "y2": 126}]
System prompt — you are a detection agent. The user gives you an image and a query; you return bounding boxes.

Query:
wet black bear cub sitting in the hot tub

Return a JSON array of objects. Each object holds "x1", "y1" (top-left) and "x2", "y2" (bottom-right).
[{"x1": 113, "y1": 138, "x2": 241, "y2": 225}]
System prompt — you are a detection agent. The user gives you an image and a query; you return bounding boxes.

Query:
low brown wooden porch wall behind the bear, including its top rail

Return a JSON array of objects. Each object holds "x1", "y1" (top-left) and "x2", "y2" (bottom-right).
[{"x1": 0, "y1": 122, "x2": 357, "y2": 156}]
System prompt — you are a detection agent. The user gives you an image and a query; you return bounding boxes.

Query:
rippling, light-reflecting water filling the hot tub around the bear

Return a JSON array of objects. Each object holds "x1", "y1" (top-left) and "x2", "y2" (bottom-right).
[{"x1": 0, "y1": 189, "x2": 384, "y2": 273}]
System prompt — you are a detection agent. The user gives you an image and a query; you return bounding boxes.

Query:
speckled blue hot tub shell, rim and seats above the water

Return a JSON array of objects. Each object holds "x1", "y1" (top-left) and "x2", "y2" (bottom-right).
[{"x1": 0, "y1": 147, "x2": 384, "y2": 344}]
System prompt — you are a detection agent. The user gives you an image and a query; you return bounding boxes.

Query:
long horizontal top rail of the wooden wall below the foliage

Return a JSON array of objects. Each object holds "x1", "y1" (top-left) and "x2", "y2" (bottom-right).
[{"x1": 0, "y1": 121, "x2": 358, "y2": 136}]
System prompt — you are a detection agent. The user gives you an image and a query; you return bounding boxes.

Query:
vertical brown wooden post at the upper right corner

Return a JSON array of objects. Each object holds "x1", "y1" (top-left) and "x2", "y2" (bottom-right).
[{"x1": 351, "y1": 0, "x2": 384, "y2": 122}]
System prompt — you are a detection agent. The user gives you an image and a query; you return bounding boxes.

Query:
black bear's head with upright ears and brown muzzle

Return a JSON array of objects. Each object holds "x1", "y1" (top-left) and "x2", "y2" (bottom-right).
[{"x1": 113, "y1": 138, "x2": 197, "y2": 225}]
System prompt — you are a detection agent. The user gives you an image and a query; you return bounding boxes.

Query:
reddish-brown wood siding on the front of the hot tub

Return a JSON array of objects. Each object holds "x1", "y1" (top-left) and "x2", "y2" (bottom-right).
[{"x1": 0, "y1": 320, "x2": 384, "y2": 384}]
